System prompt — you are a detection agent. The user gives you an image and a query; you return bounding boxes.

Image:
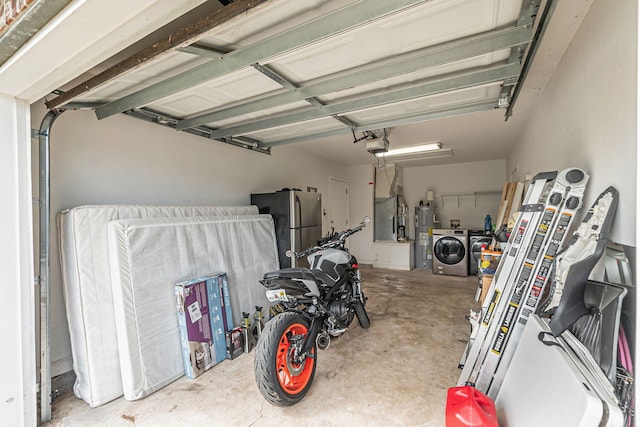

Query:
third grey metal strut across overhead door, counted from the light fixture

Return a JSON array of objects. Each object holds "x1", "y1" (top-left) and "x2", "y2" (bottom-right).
[{"x1": 177, "y1": 26, "x2": 532, "y2": 130}]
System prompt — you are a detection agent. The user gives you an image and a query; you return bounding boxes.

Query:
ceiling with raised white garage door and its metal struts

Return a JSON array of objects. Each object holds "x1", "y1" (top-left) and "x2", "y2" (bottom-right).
[{"x1": 20, "y1": 0, "x2": 590, "y2": 166}]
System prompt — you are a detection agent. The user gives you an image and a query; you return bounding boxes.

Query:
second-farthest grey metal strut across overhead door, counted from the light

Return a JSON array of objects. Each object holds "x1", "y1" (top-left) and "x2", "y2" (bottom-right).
[{"x1": 206, "y1": 64, "x2": 520, "y2": 138}]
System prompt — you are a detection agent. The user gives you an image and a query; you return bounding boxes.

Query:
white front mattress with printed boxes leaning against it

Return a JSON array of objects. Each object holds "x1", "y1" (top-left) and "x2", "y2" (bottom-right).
[{"x1": 109, "y1": 215, "x2": 278, "y2": 400}]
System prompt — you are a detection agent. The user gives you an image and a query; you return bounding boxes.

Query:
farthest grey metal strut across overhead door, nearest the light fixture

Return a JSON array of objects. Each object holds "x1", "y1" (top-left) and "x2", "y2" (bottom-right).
[{"x1": 261, "y1": 100, "x2": 498, "y2": 147}]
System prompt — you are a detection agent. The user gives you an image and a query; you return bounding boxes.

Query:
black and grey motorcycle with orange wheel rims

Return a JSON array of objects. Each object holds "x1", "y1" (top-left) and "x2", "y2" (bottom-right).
[{"x1": 254, "y1": 217, "x2": 370, "y2": 406}]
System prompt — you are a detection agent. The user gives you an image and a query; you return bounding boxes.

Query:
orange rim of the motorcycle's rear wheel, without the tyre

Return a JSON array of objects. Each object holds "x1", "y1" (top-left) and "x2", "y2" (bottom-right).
[{"x1": 276, "y1": 323, "x2": 314, "y2": 394}]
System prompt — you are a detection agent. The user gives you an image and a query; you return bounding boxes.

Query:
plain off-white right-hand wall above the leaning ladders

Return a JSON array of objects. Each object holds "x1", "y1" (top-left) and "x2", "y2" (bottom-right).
[{"x1": 507, "y1": 0, "x2": 637, "y2": 246}]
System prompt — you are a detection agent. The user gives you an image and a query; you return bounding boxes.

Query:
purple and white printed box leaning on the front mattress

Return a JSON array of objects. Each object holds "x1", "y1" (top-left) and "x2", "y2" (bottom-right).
[{"x1": 175, "y1": 279, "x2": 215, "y2": 378}]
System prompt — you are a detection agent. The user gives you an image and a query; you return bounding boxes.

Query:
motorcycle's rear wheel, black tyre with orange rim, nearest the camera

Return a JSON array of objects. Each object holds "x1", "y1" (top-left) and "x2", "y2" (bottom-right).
[{"x1": 254, "y1": 312, "x2": 316, "y2": 406}]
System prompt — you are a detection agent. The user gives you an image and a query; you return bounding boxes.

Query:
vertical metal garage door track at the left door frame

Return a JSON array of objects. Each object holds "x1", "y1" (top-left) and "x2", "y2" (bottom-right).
[{"x1": 38, "y1": 109, "x2": 65, "y2": 423}]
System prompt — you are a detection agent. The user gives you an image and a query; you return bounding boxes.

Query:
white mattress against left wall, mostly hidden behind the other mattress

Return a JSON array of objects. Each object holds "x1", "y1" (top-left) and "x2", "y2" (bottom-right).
[{"x1": 58, "y1": 205, "x2": 258, "y2": 407}]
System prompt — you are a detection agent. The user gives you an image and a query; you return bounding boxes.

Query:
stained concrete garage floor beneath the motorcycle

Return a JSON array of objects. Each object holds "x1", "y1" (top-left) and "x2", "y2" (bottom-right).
[{"x1": 46, "y1": 267, "x2": 478, "y2": 427}]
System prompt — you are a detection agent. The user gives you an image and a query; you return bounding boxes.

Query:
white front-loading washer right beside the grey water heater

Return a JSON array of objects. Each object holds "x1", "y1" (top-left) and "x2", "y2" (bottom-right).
[{"x1": 433, "y1": 228, "x2": 469, "y2": 276}]
